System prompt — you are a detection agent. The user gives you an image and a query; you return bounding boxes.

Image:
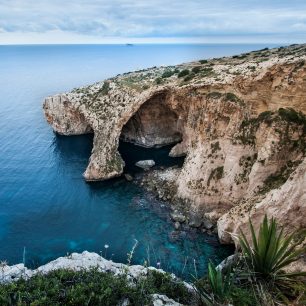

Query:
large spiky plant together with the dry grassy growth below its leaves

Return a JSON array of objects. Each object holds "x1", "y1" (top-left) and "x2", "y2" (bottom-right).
[{"x1": 239, "y1": 216, "x2": 306, "y2": 305}]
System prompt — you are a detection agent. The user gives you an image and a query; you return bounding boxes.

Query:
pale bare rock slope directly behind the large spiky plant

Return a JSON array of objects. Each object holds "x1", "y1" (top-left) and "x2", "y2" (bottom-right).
[{"x1": 218, "y1": 160, "x2": 306, "y2": 243}]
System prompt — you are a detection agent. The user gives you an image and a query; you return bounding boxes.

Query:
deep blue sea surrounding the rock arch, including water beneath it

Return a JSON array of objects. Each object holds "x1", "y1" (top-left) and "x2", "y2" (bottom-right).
[{"x1": 0, "y1": 44, "x2": 280, "y2": 278}]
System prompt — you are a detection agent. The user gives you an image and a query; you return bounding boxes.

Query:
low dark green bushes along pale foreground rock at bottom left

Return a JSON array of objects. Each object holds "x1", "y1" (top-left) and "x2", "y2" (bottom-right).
[{"x1": 0, "y1": 269, "x2": 191, "y2": 306}]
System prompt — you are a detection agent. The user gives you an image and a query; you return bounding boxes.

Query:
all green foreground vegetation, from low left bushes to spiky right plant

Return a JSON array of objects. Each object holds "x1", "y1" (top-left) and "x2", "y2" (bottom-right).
[{"x1": 0, "y1": 216, "x2": 306, "y2": 306}]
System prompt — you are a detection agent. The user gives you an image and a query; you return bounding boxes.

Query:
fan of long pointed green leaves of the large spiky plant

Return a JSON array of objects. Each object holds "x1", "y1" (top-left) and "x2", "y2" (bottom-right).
[{"x1": 239, "y1": 216, "x2": 305, "y2": 280}]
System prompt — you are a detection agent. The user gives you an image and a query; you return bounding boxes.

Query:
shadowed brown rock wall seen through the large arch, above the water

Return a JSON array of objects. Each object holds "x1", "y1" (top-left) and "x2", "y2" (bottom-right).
[{"x1": 121, "y1": 94, "x2": 182, "y2": 147}]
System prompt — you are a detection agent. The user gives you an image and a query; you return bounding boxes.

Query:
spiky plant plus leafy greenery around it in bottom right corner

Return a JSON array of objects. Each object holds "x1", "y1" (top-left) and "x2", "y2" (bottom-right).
[{"x1": 196, "y1": 216, "x2": 306, "y2": 306}]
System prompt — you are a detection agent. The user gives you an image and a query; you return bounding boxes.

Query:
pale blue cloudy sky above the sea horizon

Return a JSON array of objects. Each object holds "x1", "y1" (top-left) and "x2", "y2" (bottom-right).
[{"x1": 0, "y1": 0, "x2": 306, "y2": 44}]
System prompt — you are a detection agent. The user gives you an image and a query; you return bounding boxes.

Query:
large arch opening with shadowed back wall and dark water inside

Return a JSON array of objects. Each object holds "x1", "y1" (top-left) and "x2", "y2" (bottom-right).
[{"x1": 119, "y1": 93, "x2": 184, "y2": 172}]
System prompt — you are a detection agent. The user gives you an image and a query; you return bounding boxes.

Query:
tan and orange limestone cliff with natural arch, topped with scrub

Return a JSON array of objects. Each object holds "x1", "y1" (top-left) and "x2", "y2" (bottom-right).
[{"x1": 44, "y1": 45, "x2": 306, "y2": 251}]
